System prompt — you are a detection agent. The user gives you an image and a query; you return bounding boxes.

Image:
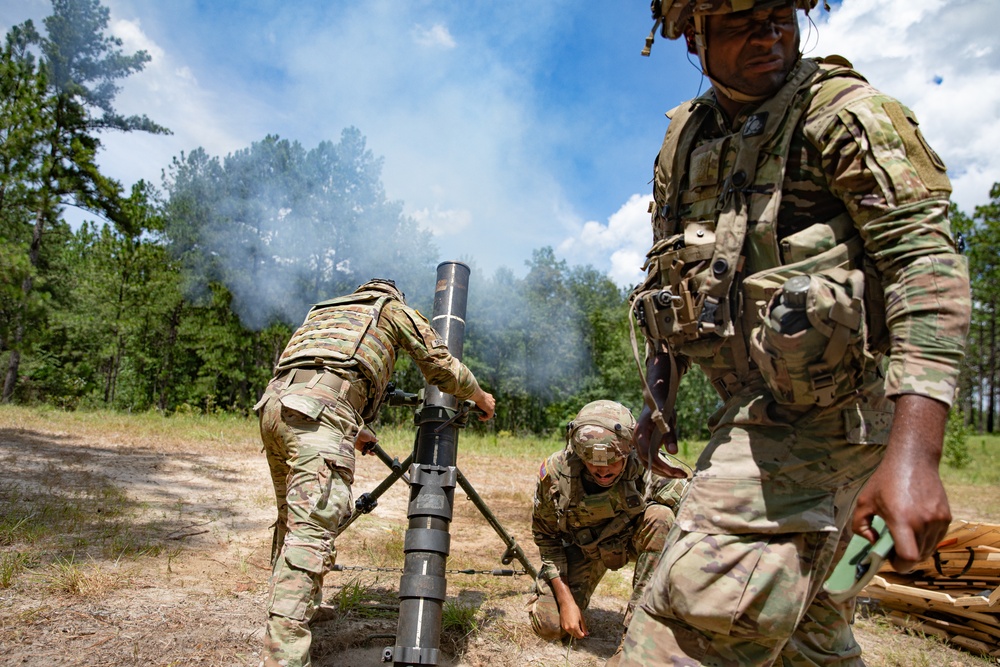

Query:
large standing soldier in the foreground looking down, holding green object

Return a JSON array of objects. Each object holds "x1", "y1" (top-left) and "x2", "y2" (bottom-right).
[{"x1": 621, "y1": 0, "x2": 970, "y2": 667}]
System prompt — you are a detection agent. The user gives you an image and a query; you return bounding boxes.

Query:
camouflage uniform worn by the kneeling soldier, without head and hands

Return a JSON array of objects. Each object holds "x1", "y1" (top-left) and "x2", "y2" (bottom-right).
[{"x1": 528, "y1": 401, "x2": 686, "y2": 640}]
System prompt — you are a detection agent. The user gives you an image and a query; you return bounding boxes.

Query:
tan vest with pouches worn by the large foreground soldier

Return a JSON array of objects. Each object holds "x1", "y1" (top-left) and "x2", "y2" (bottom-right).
[{"x1": 632, "y1": 57, "x2": 884, "y2": 405}]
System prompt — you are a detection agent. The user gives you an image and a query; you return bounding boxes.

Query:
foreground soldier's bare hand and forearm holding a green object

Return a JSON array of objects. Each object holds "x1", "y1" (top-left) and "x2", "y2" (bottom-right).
[{"x1": 851, "y1": 394, "x2": 951, "y2": 572}]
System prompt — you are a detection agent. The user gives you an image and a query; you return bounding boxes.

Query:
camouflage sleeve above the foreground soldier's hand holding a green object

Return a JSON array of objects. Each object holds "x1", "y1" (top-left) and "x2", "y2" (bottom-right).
[{"x1": 806, "y1": 84, "x2": 971, "y2": 405}]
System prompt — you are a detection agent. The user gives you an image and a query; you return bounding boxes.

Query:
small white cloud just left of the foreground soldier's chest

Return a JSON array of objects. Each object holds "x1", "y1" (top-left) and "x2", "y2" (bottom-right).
[{"x1": 557, "y1": 194, "x2": 652, "y2": 287}]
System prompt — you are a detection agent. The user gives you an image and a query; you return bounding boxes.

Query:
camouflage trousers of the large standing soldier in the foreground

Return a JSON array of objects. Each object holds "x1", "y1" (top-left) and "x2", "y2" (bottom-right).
[{"x1": 619, "y1": 393, "x2": 891, "y2": 667}]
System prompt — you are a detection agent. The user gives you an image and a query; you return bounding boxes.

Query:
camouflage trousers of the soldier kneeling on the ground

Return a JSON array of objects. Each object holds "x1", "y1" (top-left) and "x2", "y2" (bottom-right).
[{"x1": 528, "y1": 503, "x2": 674, "y2": 641}]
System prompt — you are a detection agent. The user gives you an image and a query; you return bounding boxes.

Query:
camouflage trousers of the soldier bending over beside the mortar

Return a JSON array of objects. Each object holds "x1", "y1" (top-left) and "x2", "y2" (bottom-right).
[{"x1": 260, "y1": 378, "x2": 358, "y2": 667}]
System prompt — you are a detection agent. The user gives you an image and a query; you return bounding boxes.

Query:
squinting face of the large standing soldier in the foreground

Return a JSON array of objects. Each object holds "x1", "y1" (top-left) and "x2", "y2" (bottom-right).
[{"x1": 705, "y1": 4, "x2": 799, "y2": 96}]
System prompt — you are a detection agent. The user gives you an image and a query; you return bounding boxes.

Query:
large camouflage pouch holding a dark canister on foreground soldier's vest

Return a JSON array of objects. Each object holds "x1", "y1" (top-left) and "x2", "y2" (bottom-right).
[{"x1": 750, "y1": 269, "x2": 866, "y2": 406}]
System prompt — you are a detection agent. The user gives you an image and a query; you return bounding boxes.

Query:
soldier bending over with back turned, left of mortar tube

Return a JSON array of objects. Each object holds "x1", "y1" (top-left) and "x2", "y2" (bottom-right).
[{"x1": 255, "y1": 279, "x2": 494, "y2": 667}]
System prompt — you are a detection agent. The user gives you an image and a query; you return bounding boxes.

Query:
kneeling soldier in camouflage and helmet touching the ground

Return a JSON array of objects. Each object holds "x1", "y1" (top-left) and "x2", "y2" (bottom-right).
[{"x1": 528, "y1": 401, "x2": 684, "y2": 640}]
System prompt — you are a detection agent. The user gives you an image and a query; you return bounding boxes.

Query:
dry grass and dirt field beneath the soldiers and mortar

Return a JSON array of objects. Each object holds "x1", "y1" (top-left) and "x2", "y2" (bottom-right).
[{"x1": 0, "y1": 406, "x2": 1000, "y2": 667}]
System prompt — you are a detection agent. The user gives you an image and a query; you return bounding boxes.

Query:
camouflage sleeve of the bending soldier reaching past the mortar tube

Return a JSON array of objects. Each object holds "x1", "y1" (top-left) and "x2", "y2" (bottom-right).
[{"x1": 380, "y1": 301, "x2": 479, "y2": 400}]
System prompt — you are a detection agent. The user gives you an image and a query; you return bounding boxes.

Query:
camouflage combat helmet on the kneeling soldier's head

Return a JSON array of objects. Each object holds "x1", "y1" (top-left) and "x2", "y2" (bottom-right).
[{"x1": 566, "y1": 401, "x2": 635, "y2": 466}]
